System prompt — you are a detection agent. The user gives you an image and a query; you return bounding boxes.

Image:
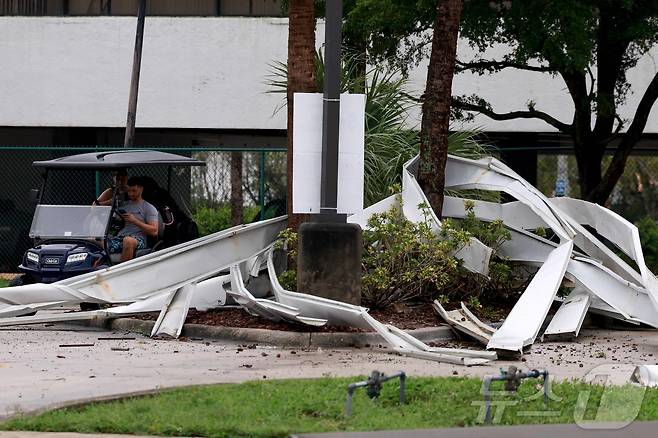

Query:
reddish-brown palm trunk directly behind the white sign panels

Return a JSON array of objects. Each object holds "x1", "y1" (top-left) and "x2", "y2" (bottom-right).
[{"x1": 287, "y1": 0, "x2": 317, "y2": 230}]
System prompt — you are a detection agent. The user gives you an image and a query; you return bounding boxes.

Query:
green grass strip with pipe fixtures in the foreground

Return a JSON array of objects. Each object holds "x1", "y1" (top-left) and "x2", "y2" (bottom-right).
[{"x1": 0, "y1": 376, "x2": 658, "y2": 437}]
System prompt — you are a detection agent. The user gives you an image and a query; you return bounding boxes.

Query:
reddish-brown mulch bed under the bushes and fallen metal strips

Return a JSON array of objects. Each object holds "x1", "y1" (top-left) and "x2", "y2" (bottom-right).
[{"x1": 135, "y1": 304, "x2": 443, "y2": 333}]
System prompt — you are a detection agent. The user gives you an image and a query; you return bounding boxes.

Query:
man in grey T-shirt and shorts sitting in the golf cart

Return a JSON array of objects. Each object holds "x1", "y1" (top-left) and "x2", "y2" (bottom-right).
[{"x1": 107, "y1": 177, "x2": 159, "y2": 262}]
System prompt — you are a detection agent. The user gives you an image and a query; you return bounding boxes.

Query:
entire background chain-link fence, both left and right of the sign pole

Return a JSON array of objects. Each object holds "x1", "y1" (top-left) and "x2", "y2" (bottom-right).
[{"x1": 5, "y1": 146, "x2": 658, "y2": 272}]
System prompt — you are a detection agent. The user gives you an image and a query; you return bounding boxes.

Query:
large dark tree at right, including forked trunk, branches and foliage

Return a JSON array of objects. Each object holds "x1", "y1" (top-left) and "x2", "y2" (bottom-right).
[{"x1": 345, "y1": 0, "x2": 658, "y2": 204}]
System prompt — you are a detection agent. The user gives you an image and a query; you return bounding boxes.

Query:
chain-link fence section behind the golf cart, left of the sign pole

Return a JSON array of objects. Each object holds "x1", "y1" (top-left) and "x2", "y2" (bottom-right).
[{"x1": 0, "y1": 146, "x2": 286, "y2": 272}]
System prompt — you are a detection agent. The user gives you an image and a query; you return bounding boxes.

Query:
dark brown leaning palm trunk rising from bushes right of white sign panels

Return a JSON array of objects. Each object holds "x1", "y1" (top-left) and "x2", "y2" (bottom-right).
[{"x1": 418, "y1": 0, "x2": 462, "y2": 217}]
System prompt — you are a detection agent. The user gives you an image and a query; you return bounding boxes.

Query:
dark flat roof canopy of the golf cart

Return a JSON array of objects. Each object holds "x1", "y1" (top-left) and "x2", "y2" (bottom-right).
[{"x1": 32, "y1": 150, "x2": 206, "y2": 170}]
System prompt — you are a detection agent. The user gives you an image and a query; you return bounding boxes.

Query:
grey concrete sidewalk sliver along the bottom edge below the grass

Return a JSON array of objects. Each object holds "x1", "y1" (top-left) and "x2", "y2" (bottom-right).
[{"x1": 294, "y1": 421, "x2": 658, "y2": 438}]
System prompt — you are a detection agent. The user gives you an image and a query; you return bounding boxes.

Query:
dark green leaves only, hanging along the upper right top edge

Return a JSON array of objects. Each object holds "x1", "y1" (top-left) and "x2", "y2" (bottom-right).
[{"x1": 343, "y1": 0, "x2": 658, "y2": 85}]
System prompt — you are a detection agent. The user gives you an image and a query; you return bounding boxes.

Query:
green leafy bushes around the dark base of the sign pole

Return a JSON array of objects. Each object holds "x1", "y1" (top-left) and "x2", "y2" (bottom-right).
[{"x1": 278, "y1": 198, "x2": 528, "y2": 310}]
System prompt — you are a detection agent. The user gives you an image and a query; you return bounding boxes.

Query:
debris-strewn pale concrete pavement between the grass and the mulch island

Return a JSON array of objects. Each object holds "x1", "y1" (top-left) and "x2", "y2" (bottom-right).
[{"x1": 0, "y1": 325, "x2": 658, "y2": 417}]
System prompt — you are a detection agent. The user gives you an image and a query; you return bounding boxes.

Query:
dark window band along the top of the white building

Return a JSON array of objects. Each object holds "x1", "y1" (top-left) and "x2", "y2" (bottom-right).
[{"x1": 0, "y1": 0, "x2": 284, "y2": 17}]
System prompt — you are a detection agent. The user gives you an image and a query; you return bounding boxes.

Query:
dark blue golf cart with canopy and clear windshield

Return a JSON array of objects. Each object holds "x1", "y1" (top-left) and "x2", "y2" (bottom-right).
[{"x1": 11, "y1": 150, "x2": 205, "y2": 286}]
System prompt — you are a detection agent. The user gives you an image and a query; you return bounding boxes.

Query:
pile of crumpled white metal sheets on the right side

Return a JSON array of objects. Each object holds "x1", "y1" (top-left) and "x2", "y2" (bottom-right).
[{"x1": 354, "y1": 156, "x2": 658, "y2": 351}]
